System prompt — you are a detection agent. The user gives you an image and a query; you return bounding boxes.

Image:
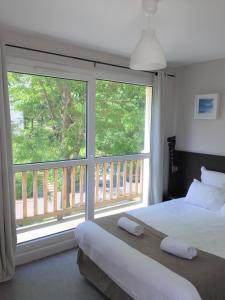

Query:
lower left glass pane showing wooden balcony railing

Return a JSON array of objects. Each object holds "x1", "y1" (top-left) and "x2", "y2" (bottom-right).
[{"x1": 14, "y1": 165, "x2": 86, "y2": 243}]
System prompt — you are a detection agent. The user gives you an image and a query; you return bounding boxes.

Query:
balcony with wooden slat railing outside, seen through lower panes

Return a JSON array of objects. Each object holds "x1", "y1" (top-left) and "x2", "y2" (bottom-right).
[{"x1": 14, "y1": 158, "x2": 144, "y2": 243}]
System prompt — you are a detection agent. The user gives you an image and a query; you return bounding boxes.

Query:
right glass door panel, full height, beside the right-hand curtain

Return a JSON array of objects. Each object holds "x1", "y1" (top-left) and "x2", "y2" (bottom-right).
[{"x1": 95, "y1": 80, "x2": 151, "y2": 217}]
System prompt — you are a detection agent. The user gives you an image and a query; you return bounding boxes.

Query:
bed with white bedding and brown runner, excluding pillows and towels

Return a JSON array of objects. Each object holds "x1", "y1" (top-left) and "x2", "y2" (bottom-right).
[{"x1": 75, "y1": 155, "x2": 225, "y2": 300}]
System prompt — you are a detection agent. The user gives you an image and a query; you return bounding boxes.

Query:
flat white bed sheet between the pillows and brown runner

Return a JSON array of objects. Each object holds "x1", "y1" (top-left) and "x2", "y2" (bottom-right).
[{"x1": 129, "y1": 198, "x2": 225, "y2": 259}]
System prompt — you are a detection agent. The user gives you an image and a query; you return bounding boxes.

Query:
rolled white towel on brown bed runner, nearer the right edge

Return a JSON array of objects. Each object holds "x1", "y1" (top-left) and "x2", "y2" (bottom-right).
[{"x1": 160, "y1": 237, "x2": 198, "y2": 259}]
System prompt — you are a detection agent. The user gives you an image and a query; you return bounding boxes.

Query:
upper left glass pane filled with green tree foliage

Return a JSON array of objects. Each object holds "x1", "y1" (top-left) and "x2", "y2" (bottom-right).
[{"x1": 8, "y1": 72, "x2": 87, "y2": 164}]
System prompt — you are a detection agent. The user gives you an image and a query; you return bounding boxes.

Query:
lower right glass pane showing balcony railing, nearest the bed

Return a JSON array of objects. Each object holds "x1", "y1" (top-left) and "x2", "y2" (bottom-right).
[{"x1": 95, "y1": 160, "x2": 144, "y2": 218}]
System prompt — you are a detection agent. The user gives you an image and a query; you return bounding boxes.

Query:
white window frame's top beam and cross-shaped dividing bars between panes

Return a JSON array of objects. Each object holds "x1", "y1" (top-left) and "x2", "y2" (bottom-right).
[{"x1": 7, "y1": 47, "x2": 152, "y2": 262}]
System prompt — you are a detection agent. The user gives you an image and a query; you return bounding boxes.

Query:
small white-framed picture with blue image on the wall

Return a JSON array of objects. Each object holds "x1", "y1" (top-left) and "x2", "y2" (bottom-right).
[{"x1": 194, "y1": 94, "x2": 219, "y2": 120}]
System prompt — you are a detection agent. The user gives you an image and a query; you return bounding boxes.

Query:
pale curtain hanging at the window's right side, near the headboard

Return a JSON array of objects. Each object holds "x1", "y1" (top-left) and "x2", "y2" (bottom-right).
[{"x1": 149, "y1": 72, "x2": 176, "y2": 204}]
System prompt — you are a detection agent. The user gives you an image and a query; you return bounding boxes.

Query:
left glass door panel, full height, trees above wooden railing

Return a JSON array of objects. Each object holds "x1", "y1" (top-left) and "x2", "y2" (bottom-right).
[{"x1": 8, "y1": 72, "x2": 88, "y2": 242}]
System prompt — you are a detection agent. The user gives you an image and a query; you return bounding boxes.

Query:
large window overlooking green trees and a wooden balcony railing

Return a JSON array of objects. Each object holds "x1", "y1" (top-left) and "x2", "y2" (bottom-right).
[{"x1": 8, "y1": 52, "x2": 151, "y2": 243}]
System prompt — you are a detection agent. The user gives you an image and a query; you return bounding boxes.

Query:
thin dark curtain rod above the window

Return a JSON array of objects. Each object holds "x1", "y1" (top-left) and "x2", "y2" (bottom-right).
[{"x1": 6, "y1": 44, "x2": 176, "y2": 78}]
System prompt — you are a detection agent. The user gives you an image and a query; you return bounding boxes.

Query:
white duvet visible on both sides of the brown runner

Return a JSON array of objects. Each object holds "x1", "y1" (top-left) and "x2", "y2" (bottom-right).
[{"x1": 75, "y1": 199, "x2": 225, "y2": 300}]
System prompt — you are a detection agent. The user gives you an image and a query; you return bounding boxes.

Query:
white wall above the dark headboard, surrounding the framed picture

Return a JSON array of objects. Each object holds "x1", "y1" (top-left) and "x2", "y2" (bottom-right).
[{"x1": 176, "y1": 59, "x2": 225, "y2": 155}]
